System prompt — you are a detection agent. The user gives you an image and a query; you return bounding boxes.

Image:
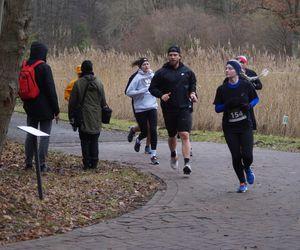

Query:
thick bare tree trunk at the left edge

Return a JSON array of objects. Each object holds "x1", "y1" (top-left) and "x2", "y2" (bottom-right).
[{"x1": 0, "y1": 0, "x2": 30, "y2": 156}]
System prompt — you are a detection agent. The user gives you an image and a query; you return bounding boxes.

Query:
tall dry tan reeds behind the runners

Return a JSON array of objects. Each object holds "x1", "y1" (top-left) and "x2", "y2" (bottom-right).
[{"x1": 48, "y1": 45, "x2": 300, "y2": 137}]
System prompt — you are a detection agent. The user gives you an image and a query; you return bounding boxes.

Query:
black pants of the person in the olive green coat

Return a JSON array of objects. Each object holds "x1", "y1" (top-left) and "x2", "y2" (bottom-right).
[{"x1": 79, "y1": 131, "x2": 100, "y2": 168}]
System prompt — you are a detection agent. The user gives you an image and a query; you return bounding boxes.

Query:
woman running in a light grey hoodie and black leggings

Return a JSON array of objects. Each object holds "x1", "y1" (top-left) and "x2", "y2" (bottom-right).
[{"x1": 126, "y1": 57, "x2": 159, "y2": 165}]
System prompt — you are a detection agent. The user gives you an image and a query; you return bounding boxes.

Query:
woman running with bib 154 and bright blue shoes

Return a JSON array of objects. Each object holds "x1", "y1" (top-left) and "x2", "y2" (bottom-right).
[{"x1": 214, "y1": 59, "x2": 259, "y2": 193}]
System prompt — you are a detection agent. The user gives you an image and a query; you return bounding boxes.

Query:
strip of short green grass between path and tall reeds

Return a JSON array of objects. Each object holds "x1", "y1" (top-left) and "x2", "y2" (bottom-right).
[{"x1": 15, "y1": 106, "x2": 300, "y2": 152}]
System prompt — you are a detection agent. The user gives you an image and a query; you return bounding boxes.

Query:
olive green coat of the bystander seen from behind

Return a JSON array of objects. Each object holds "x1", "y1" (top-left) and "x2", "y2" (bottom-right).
[{"x1": 68, "y1": 75, "x2": 107, "y2": 134}]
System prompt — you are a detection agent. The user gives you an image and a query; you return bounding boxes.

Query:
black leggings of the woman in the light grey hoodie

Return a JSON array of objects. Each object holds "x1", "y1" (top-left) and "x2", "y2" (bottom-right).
[{"x1": 135, "y1": 109, "x2": 157, "y2": 150}]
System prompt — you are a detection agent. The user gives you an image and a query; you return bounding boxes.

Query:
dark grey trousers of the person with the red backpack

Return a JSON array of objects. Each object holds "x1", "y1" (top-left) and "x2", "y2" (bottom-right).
[{"x1": 25, "y1": 116, "x2": 52, "y2": 166}]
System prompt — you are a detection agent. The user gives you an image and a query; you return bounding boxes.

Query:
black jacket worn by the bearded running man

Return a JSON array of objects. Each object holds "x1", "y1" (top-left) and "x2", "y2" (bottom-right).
[{"x1": 149, "y1": 63, "x2": 197, "y2": 110}]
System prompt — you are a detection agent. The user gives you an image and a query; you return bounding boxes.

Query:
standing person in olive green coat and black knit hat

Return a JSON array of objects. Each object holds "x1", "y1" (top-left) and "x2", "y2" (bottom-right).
[{"x1": 68, "y1": 60, "x2": 107, "y2": 170}]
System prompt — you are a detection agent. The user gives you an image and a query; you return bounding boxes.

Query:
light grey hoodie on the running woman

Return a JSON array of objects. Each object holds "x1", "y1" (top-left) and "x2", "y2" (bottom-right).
[{"x1": 126, "y1": 69, "x2": 157, "y2": 113}]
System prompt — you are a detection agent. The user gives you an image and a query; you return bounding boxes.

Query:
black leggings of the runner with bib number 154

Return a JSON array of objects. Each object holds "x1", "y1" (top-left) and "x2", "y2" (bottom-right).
[{"x1": 224, "y1": 128, "x2": 253, "y2": 183}]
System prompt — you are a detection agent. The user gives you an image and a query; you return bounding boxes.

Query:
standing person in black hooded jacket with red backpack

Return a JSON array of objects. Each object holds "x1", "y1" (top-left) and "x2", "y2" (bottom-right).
[{"x1": 19, "y1": 42, "x2": 60, "y2": 172}]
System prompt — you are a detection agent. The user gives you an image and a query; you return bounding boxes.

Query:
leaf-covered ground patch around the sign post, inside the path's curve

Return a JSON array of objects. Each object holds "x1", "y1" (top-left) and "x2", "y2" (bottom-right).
[{"x1": 0, "y1": 142, "x2": 165, "y2": 245}]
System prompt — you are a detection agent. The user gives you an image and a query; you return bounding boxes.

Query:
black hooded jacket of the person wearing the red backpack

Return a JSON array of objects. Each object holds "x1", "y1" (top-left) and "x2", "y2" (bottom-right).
[{"x1": 23, "y1": 42, "x2": 59, "y2": 121}]
